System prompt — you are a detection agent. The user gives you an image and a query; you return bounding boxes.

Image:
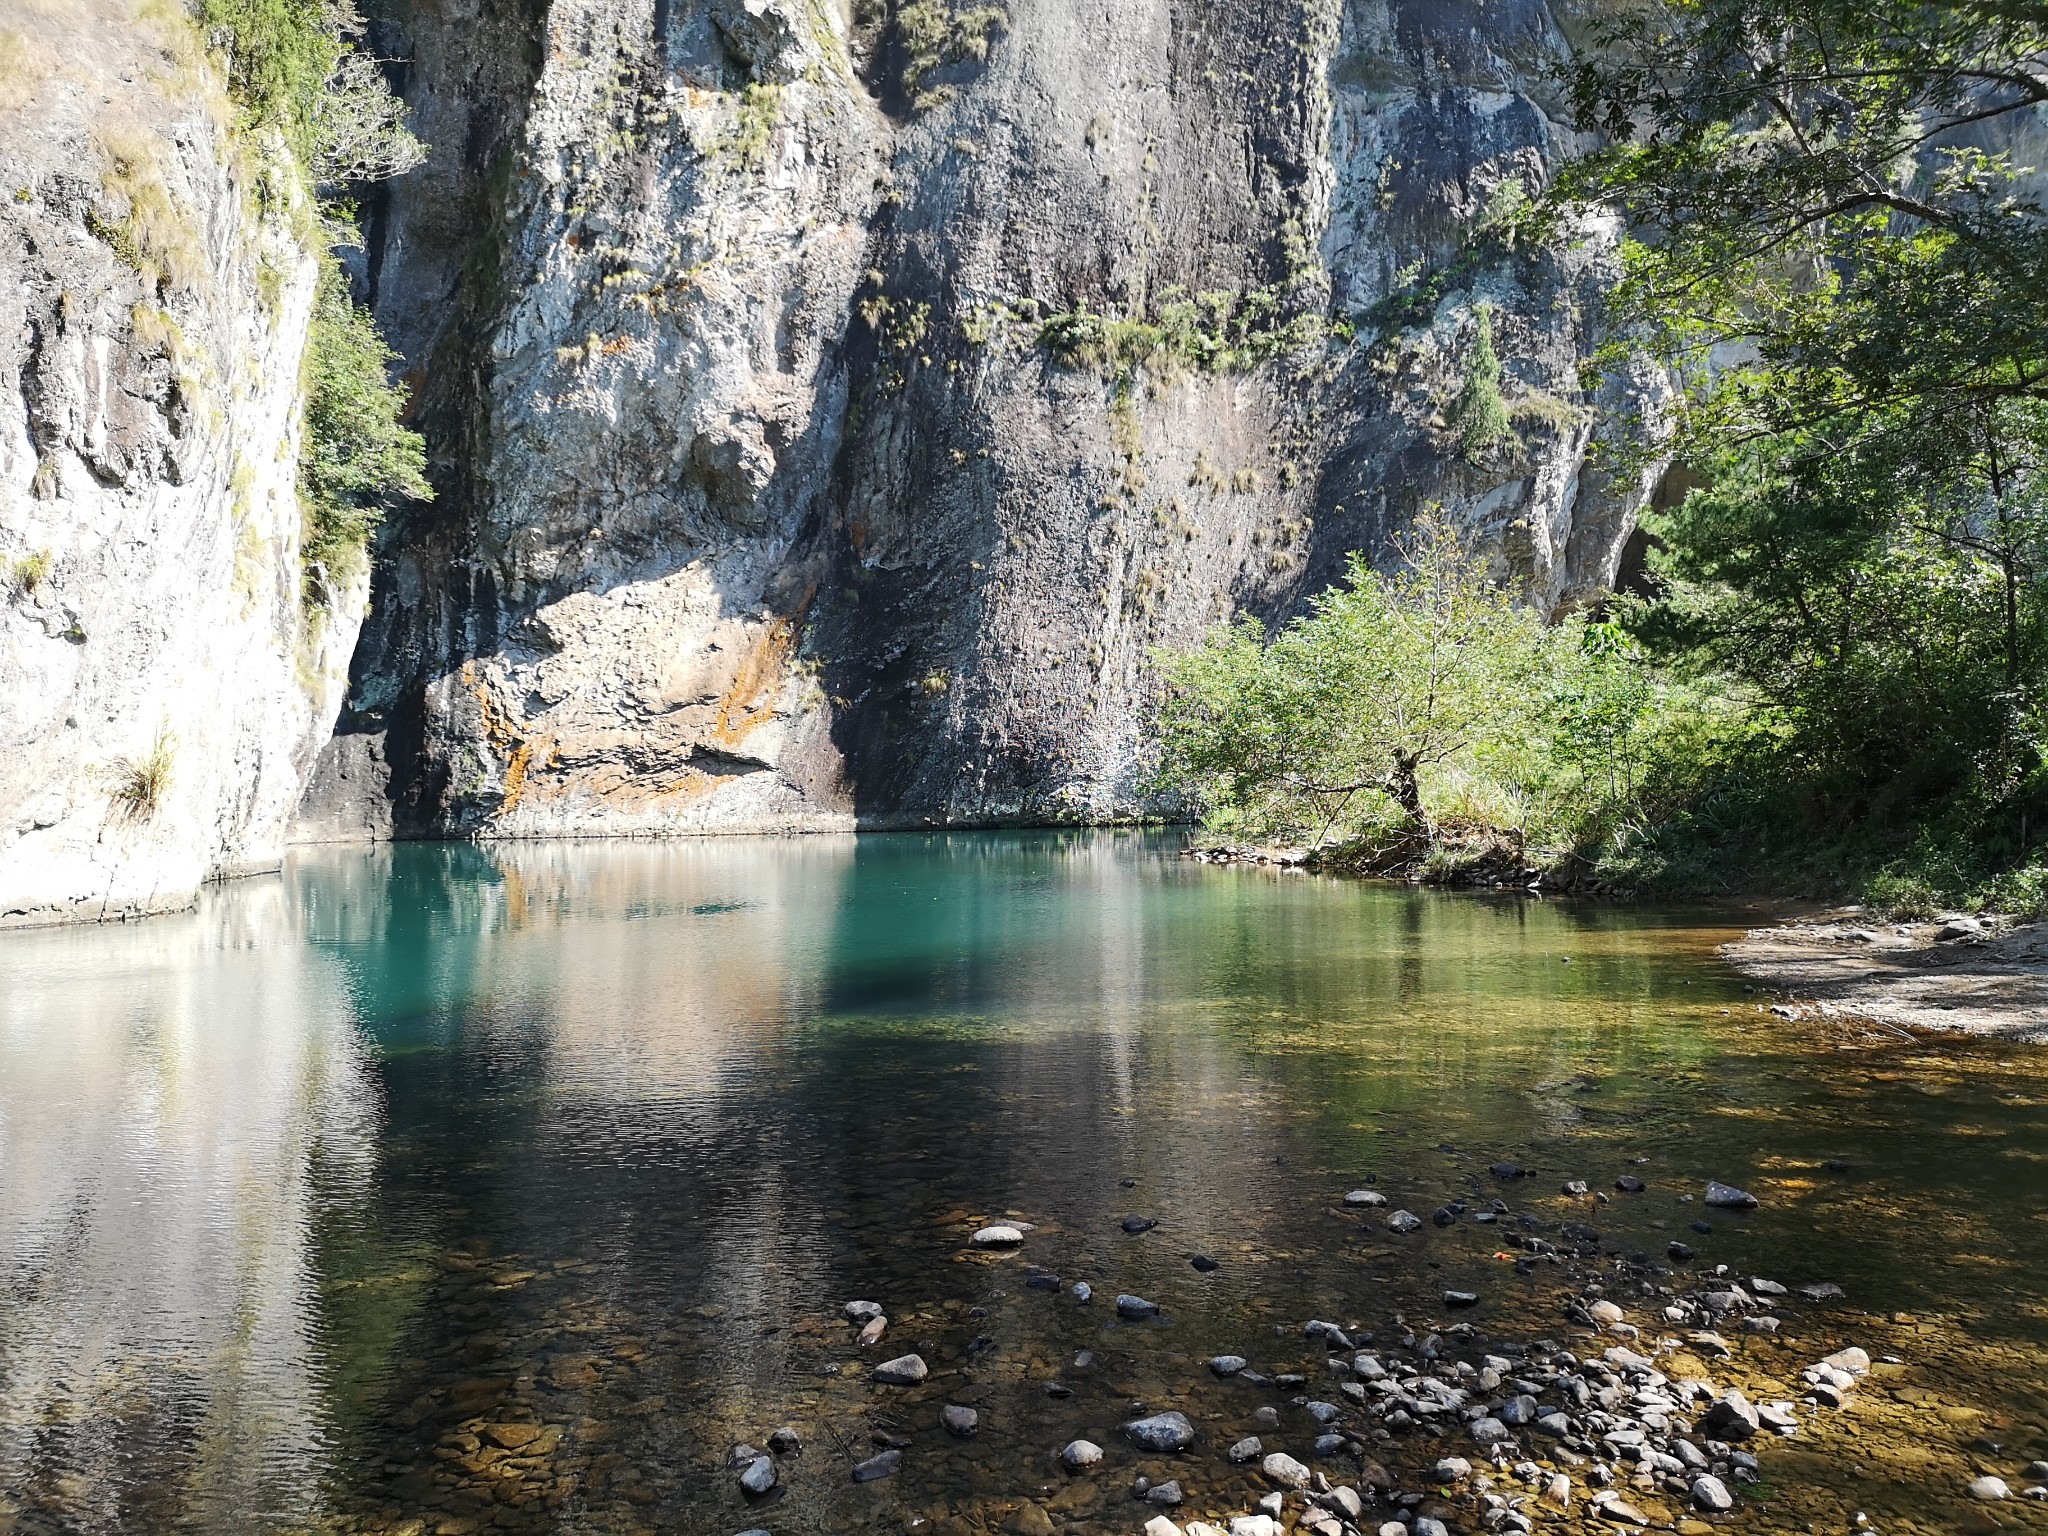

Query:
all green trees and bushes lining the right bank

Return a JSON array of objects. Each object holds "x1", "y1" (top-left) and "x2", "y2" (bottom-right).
[{"x1": 1161, "y1": 0, "x2": 2048, "y2": 911}]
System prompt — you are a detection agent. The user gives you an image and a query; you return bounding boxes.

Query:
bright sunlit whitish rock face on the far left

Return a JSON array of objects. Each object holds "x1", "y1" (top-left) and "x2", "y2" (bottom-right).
[{"x1": 0, "y1": 0, "x2": 362, "y2": 926}]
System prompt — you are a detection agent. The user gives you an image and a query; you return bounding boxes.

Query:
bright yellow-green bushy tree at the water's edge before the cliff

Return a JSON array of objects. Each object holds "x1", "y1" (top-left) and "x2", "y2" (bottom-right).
[{"x1": 1159, "y1": 512, "x2": 1655, "y2": 846}]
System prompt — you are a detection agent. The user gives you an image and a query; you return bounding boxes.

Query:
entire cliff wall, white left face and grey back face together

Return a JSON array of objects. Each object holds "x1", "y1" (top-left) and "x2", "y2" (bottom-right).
[{"x1": 0, "y1": 0, "x2": 1659, "y2": 922}]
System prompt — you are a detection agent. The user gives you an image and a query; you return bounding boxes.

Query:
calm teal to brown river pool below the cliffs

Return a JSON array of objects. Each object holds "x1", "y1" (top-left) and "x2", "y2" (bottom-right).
[{"x1": 0, "y1": 834, "x2": 2048, "y2": 1536}]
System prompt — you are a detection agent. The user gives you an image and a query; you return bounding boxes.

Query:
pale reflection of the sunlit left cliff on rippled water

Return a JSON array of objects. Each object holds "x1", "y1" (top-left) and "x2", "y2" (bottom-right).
[{"x1": 0, "y1": 881, "x2": 377, "y2": 1530}]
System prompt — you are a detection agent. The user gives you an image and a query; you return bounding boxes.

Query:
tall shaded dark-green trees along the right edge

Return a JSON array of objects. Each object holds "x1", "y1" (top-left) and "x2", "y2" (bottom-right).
[{"x1": 1546, "y1": 0, "x2": 2048, "y2": 901}]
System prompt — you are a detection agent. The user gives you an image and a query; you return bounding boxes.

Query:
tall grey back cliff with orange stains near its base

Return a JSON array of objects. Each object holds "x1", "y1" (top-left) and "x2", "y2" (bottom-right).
[{"x1": 323, "y1": 0, "x2": 1657, "y2": 836}]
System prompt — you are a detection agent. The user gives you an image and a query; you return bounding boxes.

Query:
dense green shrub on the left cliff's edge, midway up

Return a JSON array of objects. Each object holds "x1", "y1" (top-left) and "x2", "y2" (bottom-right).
[{"x1": 299, "y1": 260, "x2": 434, "y2": 604}]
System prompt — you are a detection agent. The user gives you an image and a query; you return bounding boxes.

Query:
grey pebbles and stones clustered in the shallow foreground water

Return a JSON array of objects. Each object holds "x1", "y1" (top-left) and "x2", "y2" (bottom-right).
[{"x1": 692, "y1": 1169, "x2": 2048, "y2": 1536}]
